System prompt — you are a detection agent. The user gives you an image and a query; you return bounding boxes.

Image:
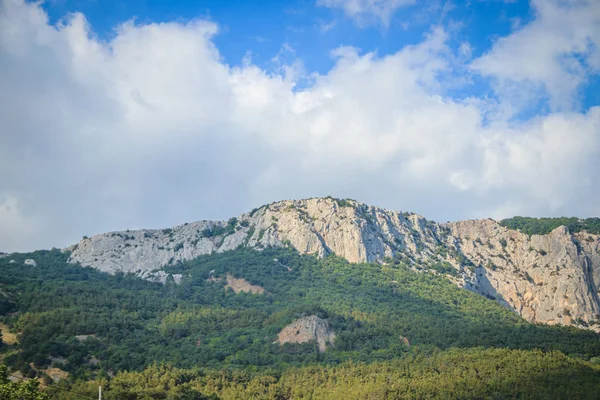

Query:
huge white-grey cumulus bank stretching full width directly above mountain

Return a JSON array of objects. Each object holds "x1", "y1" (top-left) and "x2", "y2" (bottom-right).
[{"x1": 0, "y1": 0, "x2": 600, "y2": 251}]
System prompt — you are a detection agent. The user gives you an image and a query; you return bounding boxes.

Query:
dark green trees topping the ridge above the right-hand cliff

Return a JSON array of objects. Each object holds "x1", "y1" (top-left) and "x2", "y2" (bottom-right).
[{"x1": 500, "y1": 217, "x2": 600, "y2": 235}]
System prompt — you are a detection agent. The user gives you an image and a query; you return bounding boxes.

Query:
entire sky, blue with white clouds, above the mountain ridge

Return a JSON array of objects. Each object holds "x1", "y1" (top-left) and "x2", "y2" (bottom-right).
[{"x1": 0, "y1": 0, "x2": 600, "y2": 252}]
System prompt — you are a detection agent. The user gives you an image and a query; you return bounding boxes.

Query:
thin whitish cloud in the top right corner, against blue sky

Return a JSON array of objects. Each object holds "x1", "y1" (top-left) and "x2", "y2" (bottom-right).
[{"x1": 472, "y1": 0, "x2": 600, "y2": 111}]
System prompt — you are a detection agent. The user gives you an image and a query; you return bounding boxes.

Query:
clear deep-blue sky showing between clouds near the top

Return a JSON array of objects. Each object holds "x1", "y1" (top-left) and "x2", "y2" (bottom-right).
[{"x1": 43, "y1": 0, "x2": 540, "y2": 96}]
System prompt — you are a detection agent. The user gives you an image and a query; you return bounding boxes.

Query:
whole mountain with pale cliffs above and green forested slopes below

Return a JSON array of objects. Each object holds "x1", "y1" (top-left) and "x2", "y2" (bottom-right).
[{"x1": 0, "y1": 198, "x2": 600, "y2": 400}]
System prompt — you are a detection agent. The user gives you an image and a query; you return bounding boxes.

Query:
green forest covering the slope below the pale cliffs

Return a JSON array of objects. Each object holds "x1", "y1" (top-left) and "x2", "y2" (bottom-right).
[{"x1": 0, "y1": 248, "x2": 600, "y2": 399}]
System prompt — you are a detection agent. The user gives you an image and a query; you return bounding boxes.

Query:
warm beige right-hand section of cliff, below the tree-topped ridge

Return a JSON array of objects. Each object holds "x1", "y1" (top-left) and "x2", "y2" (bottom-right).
[{"x1": 450, "y1": 220, "x2": 600, "y2": 330}]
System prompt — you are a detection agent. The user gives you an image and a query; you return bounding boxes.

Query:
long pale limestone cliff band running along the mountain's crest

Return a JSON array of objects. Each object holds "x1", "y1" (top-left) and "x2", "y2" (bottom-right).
[{"x1": 68, "y1": 198, "x2": 600, "y2": 330}]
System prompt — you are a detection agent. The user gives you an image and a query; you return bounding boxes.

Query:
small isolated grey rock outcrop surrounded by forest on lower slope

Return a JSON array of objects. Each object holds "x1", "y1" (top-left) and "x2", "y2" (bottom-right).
[{"x1": 275, "y1": 315, "x2": 335, "y2": 353}]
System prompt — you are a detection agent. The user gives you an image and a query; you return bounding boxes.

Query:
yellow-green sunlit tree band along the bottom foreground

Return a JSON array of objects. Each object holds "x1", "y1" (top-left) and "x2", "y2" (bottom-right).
[{"x1": 49, "y1": 348, "x2": 600, "y2": 400}]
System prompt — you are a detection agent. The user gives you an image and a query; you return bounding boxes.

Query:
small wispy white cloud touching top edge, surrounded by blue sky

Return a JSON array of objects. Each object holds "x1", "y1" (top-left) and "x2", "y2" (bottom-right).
[{"x1": 317, "y1": 0, "x2": 415, "y2": 27}]
